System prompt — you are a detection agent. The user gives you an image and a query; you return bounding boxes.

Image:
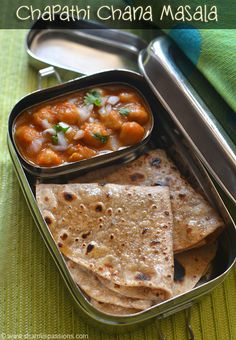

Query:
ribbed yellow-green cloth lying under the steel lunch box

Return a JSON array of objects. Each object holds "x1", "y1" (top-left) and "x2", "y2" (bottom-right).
[{"x1": 0, "y1": 30, "x2": 236, "y2": 340}]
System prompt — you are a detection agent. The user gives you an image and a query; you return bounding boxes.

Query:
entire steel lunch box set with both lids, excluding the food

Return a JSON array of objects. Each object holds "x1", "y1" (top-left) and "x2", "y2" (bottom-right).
[{"x1": 8, "y1": 17, "x2": 236, "y2": 332}]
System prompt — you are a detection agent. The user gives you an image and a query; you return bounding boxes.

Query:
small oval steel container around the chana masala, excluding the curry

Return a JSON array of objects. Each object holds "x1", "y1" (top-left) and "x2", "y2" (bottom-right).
[{"x1": 10, "y1": 71, "x2": 155, "y2": 179}]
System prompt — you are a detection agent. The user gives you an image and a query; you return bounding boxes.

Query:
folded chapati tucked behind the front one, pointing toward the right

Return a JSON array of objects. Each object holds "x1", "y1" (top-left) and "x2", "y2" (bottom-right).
[{"x1": 75, "y1": 149, "x2": 224, "y2": 253}]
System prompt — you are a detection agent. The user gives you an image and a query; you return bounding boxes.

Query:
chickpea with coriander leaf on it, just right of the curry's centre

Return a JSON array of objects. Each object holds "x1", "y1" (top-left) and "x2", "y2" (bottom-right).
[{"x1": 81, "y1": 123, "x2": 109, "y2": 148}]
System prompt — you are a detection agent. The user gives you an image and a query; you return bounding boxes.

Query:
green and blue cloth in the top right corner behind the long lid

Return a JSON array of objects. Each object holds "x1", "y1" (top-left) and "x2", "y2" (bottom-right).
[{"x1": 168, "y1": 25, "x2": 236, "y2": 112}]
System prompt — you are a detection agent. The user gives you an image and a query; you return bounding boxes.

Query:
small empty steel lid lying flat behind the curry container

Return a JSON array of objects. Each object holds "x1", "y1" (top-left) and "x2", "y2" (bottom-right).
[{"x1": 25, "y1": 17, "x2": 147, "y2": 79}]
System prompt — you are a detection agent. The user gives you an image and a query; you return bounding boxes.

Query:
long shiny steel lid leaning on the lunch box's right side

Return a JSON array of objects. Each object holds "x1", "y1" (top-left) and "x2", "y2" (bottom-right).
[{"x1": 138, "y1": 36, "x2": 236, "y2": 203}]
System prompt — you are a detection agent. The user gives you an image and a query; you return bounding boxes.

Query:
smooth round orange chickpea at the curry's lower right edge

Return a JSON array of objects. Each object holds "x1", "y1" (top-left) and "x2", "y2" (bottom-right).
[{"x1": 120, "y1": 122, "x2": 144, "y2": 145}]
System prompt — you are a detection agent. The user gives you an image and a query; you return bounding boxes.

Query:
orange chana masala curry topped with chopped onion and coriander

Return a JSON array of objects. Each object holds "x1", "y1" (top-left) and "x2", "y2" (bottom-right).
[{"x1": 14, "y1": 85, "x2": 151, "y2": 167}]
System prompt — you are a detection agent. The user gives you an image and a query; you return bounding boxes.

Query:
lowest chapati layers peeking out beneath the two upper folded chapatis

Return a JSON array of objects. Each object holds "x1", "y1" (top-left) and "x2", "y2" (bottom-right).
[{"x1": 63, "y1": 243, "x2": 217, "y2": 315}]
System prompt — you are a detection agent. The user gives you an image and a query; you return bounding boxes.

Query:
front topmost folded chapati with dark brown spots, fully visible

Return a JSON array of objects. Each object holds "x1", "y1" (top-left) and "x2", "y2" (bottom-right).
[{"x1": 36, "y1": 183, "x2": 173, "y2": 300}]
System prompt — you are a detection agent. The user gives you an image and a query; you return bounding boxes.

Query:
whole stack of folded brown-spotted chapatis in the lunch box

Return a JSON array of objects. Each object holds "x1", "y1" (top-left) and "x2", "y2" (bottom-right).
[{"x1": 36, "y1": 150, "x2": 223, "y2": 315}]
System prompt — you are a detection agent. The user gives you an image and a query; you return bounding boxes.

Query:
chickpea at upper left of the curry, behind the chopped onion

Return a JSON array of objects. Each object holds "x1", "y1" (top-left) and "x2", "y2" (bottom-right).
[{"x1": 54, "y1": 102, "x2": 79, "y2": 125}]
